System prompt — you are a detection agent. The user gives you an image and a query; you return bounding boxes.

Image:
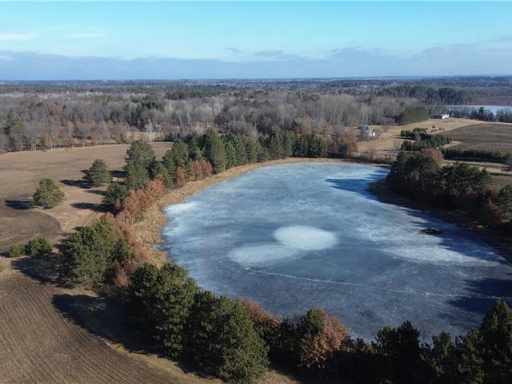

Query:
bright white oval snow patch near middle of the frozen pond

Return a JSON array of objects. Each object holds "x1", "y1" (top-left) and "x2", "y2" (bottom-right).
[{"x1": 274, "y1": 225, "x2": 338, "y2": 251}]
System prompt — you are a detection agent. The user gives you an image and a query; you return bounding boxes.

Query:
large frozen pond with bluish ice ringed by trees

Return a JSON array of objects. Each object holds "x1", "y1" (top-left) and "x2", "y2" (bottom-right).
[{"x1": 164, "y1": 163, "x2": 512, "y2": 337}]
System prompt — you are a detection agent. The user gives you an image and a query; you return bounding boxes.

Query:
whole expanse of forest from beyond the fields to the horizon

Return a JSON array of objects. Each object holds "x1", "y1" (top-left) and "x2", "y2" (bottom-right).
[{"x1": 0, "y1": 78, "x2": 512, "y2": 151}]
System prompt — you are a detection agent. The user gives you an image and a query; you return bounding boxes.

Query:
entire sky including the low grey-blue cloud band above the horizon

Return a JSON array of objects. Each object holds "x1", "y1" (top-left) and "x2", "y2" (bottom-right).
[{"x1": 0, "y1": 1, "x2": 512, "y2": 80}]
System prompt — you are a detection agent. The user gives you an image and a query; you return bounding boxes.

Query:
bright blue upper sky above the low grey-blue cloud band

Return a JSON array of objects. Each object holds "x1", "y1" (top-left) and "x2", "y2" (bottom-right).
[{"x1": 0, "y1": 1, "x2": 512, "y2": 79}]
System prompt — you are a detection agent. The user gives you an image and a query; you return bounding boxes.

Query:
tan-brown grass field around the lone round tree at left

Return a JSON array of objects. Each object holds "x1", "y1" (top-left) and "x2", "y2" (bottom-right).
[{"x1": 0, "y1": 143, "x2": 169, "y2": 252}]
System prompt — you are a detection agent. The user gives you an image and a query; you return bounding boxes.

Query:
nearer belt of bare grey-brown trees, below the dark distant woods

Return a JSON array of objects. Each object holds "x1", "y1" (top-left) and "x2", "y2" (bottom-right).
[{"x1": 0, "y1": 86, "x2": 421, "y2": 151}]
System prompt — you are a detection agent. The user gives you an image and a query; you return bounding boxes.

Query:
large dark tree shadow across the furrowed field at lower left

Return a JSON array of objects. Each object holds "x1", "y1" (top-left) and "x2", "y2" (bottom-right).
[{"x1": 52, "y1": 294, "x2": 163, "y2": 356}]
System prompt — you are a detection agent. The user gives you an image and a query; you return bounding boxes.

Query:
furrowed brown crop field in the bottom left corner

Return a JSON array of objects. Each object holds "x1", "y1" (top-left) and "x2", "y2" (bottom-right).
[{"x1": 0, "y1": 271, "x2": 183, "y2": 384}]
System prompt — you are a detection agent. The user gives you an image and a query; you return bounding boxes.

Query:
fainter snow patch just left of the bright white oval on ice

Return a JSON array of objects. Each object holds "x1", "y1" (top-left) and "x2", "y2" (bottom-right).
[{"x1": 228, "y1": 243, "x2": 297, "y2": 267}]
